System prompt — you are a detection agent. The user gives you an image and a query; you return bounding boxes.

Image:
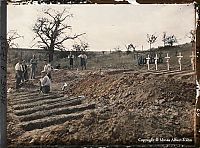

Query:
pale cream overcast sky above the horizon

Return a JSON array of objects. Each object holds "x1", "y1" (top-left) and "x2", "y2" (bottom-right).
[{"x1": 7, "y1": 4, "x2": 195, "y2": 51}]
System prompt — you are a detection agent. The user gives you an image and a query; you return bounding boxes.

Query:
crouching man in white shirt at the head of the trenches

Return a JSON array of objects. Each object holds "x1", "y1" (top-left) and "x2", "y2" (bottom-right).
[{"x1": 39, "y1": 71, "x2": 51, "y2": 94}]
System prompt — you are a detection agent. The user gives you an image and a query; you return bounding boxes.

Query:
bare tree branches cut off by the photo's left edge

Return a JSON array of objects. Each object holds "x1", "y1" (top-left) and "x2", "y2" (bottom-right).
[{"x1": 7, "y1": 30, "x2": 23, "y2": 48}]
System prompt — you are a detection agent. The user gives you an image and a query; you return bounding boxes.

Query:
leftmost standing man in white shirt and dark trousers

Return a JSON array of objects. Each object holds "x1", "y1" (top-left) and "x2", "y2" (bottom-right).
[{"x1": 15, "y1": 59, "x2": 23, "y2": 89}]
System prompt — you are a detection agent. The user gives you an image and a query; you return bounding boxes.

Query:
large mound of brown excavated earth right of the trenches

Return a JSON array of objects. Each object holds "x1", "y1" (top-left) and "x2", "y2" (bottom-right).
[{"x1": 65, "y1": 73, "x2": 195, "y2": 143}]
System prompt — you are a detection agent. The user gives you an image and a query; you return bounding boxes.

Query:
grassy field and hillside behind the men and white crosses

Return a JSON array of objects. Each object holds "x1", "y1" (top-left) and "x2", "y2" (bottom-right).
[{"x1": 8, "y1": 44, "x2": 192, "y2": 70}]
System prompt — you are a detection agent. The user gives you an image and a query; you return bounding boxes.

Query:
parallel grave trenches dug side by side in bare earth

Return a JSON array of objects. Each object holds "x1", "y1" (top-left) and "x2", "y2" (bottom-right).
[{"x1": 12, "y1": 93, "x2": 95, "y2": 131}]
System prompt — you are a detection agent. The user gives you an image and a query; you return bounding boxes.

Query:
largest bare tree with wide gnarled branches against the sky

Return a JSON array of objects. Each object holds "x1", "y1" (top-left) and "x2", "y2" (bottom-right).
[{"x1": 33, "y1": 9, "x2": 85, "y2": 62}]
